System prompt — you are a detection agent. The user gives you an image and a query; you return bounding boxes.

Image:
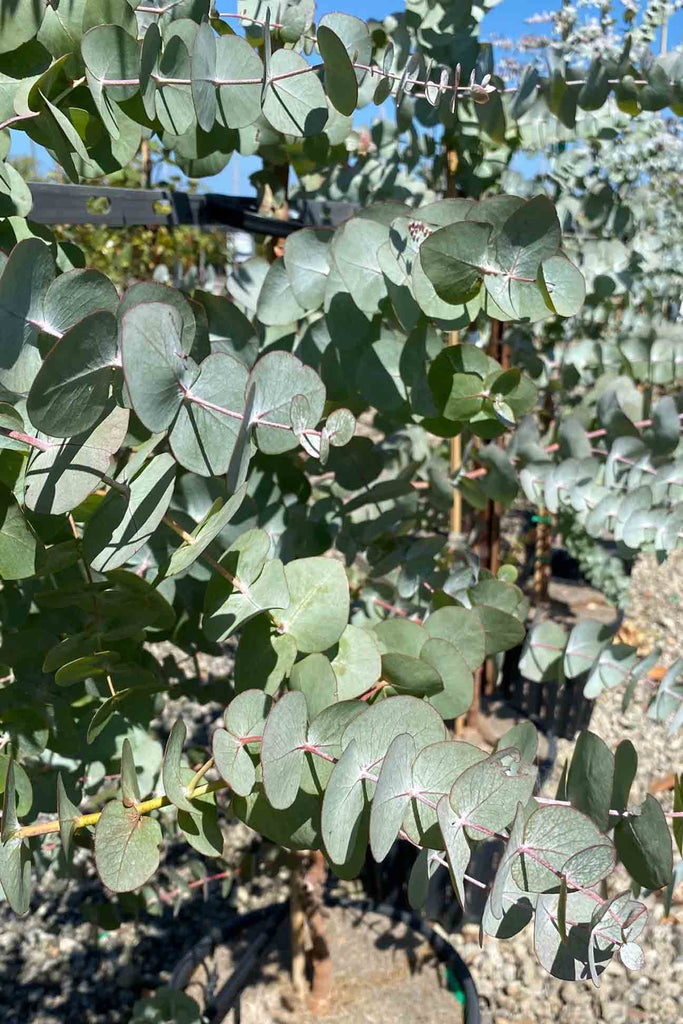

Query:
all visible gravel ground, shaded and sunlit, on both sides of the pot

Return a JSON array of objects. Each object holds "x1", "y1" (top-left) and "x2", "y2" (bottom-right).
[{"x1": 0, "y1": 552, "x2": 683, "y2": 1024}]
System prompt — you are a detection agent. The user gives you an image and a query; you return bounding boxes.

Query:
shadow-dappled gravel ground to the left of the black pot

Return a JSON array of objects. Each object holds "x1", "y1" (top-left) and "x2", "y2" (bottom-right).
[{"x1": 0, "y1": 821, "x2": 287, "y2": 1024}]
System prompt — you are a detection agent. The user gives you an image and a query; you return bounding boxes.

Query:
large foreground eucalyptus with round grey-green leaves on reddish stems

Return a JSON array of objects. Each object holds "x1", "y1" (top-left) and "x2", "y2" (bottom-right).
[{"x1": 0, "y1": 0, "x2": 683, "y2": 983}]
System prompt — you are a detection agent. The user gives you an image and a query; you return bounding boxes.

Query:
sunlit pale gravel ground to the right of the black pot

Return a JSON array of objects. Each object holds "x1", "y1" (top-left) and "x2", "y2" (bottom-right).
[{"x1": 452, "y1": 551, "x2": 683, "y2": 1024}]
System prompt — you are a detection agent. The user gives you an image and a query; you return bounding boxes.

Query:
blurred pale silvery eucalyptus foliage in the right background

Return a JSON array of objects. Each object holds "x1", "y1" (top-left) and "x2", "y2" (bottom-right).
[{"x1": 481, "y1": 99, "x2": 683, "y2": 622}]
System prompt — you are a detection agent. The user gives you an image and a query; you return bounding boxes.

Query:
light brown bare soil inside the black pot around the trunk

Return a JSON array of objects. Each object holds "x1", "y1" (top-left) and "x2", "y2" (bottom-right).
[{"x1": 185, "y1": 907, "x2": 464, "y2": 1024}]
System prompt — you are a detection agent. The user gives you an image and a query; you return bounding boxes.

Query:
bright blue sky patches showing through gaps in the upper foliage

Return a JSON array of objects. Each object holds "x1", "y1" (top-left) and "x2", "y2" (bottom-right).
[{"x1": 11, "y1": 0, "x2": 683, "y2": 196}]
